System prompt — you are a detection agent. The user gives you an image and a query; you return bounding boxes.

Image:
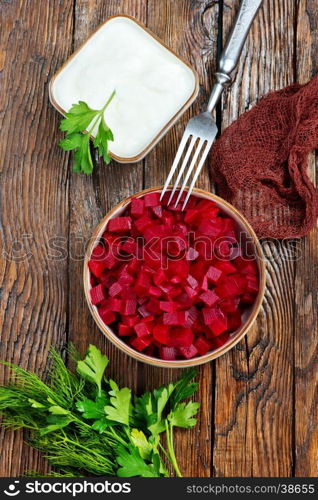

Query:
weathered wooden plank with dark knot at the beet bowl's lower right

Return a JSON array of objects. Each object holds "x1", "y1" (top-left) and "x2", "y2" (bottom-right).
[{"x1": 213, "y1": 0, "x2": 295, "y2": 476}]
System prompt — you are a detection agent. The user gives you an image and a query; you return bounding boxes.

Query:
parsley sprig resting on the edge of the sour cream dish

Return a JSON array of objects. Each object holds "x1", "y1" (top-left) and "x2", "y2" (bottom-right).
[{"x1": 59, "y1": 91, "x2": 115, "y2": 174}]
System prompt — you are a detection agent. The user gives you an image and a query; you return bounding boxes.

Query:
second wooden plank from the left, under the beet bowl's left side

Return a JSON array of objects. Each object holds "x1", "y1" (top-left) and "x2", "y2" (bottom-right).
[{"x1": 69, "y1": 0, "x2": 146, "y2": 387}]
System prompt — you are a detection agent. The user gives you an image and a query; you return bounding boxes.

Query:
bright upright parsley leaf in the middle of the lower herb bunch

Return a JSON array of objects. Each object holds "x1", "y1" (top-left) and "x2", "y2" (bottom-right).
[{"x1": 105, "y1": 380, "x2": 131, "y2": 426}]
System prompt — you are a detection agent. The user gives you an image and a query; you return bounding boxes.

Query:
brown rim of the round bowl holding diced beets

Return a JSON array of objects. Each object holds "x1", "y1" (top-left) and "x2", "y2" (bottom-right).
[{"x1": 83, "y1": 186, "x2": 266, "y2": 368}]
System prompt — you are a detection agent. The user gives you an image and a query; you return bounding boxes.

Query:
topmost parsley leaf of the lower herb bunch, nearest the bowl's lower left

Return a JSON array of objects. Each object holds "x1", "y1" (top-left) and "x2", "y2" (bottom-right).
[{"x1": 77, "y1": 344, "x2": 108, "y2": 396}]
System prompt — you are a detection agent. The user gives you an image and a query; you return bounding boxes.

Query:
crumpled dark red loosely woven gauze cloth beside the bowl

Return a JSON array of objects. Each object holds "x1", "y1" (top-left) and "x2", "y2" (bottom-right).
[{"x1": 212, "y1": 75, "x2": 318, "y2": 239}]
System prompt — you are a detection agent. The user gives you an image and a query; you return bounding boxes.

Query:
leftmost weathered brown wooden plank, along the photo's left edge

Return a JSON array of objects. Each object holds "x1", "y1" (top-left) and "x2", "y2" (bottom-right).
[{"x1": 0, "y1": 0, "x2": 72, "y2": 476}]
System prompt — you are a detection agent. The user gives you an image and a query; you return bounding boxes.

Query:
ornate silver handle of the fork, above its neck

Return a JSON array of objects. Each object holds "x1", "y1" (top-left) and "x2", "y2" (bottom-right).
[{"x1": 207, "y1": 0, "x2": 263, "y2": 113}]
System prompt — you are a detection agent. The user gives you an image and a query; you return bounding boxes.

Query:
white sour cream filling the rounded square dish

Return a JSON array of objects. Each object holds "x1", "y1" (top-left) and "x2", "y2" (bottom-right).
[{"x1": 51, "y1": 17, "x2": 197, "y2": 159}]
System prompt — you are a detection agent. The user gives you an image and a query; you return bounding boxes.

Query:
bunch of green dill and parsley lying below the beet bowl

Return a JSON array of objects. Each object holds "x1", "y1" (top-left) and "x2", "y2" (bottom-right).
[{"x1": 0, "y1": 345, "x2": 199, "y2": 477}]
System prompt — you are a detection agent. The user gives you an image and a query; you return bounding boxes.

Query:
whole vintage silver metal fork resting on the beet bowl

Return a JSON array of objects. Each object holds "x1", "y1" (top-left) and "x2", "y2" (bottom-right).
[{"x1": 160, "y1": 0, "x2": 263, "y2": 210}]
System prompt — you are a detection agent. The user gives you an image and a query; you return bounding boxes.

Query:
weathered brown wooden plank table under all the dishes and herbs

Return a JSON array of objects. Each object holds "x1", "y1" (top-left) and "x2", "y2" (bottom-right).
[{"x1": 0, "y1": 0, "x2": 318, "y2": 477}]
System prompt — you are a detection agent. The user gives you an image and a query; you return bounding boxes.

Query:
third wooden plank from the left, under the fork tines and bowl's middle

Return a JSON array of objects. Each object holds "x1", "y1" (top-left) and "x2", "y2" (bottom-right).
[{"x1": 142, "y1": 0, "x2": 218, "y2": 477}]
